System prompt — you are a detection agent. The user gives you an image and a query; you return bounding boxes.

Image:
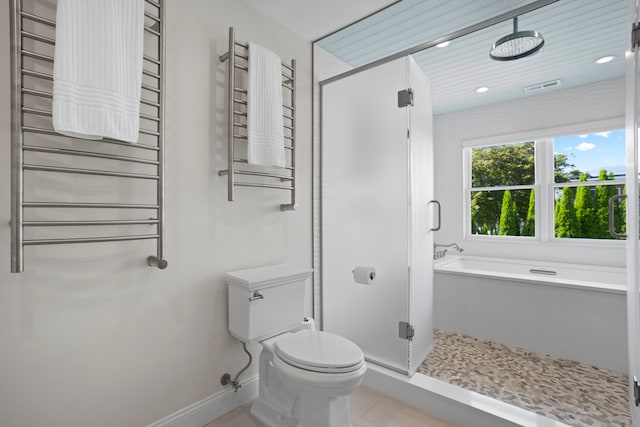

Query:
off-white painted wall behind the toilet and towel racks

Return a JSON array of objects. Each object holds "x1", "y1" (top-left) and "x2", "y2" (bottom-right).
[{"x1": 0, "y1": 0, "x2": 312, "y2": 427}]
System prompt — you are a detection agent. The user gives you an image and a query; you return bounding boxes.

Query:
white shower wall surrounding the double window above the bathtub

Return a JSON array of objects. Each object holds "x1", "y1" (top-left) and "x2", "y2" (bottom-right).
[{"x1": 434, "y1": 80, "x2": 625, "y2": 266}]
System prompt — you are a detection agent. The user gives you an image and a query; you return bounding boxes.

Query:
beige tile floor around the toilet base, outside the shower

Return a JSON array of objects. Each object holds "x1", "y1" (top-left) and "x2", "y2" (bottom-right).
[{"x1": 205, "y1": 386, "x2": 454, "y2": 427}]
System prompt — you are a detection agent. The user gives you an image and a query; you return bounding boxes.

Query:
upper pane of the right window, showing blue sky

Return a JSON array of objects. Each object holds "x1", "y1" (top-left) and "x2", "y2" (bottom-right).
[{"x1": 553, "y1": 130, "x2": 625, "y2": 182}]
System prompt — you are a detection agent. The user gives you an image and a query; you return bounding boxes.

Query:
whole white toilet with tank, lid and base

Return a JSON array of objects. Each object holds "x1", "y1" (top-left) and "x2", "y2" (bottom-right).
[{"x1": 225, "y1": 264, "x2": 367, "y2": 427}]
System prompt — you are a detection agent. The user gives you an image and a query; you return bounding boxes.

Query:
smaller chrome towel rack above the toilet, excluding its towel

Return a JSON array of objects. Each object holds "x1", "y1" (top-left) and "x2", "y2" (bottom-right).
[{"x1": 218, "y1": 27, "x2": 296, "y2": 211}]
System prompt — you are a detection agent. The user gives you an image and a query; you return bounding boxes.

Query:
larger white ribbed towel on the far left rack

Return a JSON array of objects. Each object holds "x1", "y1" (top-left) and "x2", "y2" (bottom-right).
[{"x1": 53, "y1": 0, "x2": 144, "y2": 142}]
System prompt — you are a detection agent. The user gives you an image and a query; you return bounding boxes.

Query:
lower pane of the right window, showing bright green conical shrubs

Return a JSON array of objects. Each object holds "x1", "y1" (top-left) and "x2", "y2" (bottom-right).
[{"x1": 554, "y1": 183, "x2": 626, "y2": 239}]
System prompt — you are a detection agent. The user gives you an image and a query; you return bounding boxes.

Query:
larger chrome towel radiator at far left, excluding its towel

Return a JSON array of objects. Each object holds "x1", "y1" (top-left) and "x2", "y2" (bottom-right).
[{"x1": 10, "y1": 0, "x2": 167, "y2": 273}]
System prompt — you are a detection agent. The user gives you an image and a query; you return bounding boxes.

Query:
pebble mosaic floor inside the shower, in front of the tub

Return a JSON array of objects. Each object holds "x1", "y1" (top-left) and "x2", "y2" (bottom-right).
[{"x1": 419, "y1": 330, "x2": 631, "y2": 427}]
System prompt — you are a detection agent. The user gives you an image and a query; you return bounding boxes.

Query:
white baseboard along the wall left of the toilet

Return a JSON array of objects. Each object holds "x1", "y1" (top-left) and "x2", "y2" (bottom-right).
[{"x1": 147, "y1": 375, "x2": 258, "y2": 427}]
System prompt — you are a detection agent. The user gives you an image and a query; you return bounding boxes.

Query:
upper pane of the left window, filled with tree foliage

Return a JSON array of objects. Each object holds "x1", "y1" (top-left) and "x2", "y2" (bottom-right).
[{"x1": 471, "y1": 142, "x2": 535, "y2": 188}]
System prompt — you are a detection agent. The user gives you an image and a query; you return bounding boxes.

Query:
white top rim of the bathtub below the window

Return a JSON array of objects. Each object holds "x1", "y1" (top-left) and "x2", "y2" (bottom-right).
[{"x1": 434, "y1": 256, "x2": 627, "y2": 293}]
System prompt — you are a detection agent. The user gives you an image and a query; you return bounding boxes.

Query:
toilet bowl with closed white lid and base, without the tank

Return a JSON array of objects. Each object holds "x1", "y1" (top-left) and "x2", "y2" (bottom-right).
[{"x1": 251, "y1": 329, "x2": 367, "y2": 427}]
